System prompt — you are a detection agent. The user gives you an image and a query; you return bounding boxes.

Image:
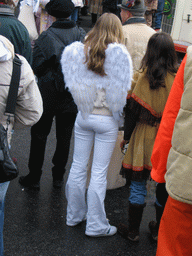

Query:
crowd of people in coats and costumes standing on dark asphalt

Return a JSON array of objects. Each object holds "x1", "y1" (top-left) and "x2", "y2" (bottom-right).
[{"x1": 0, "y1": 0, "x2": 192, "y2": 256}]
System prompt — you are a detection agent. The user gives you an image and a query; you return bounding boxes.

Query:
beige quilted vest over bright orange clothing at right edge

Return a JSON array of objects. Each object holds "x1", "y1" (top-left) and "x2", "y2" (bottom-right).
[{"x1": 165, "y1": 46, "x2": 192, "y2": 204}]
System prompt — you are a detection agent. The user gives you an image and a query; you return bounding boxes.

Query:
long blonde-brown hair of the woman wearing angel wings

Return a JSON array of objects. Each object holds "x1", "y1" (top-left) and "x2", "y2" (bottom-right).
[{"x1": 84, "y1": 13, "x2": 124, "y2": 76}]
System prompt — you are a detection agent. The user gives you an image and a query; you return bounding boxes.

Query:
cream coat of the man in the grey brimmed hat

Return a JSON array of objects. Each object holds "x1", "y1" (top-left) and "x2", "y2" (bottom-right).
[{"x1": 123, "y1": 23, "x2": 156, "y2": 71}]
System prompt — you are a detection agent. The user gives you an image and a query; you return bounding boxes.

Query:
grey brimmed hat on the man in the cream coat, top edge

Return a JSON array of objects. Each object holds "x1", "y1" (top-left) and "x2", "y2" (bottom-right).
[{"x1": 117, "y1": 0, "x2": 146, "y2": 16}]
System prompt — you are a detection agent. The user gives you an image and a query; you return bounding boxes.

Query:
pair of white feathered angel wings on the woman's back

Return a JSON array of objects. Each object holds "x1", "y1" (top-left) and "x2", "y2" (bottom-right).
[{"x1": 61, "y1": 42, "x2": 133, "y2": 118}]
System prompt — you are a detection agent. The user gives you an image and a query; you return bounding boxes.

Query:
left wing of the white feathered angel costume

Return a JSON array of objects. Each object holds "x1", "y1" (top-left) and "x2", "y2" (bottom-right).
[{"x1": 61, "y1": 42, "x2": 97, "y2": 118}]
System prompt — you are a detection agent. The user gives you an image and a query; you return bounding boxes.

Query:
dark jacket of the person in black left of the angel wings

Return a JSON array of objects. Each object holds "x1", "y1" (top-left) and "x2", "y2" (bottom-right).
[{"x1": 32, "y1": 19, "x2": 86, "y2": 113}]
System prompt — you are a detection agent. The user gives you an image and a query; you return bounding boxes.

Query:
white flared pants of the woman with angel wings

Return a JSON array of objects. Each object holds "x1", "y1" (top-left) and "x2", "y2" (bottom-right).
[{"x1": 66, "y1": 113, "x2": 118, "y2": 235}]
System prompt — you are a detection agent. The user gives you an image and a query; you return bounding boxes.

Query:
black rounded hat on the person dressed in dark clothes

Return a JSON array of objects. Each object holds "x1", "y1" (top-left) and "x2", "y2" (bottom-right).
[{"x1": 45, "y1": 0, "x2": 75, "y2": 18}]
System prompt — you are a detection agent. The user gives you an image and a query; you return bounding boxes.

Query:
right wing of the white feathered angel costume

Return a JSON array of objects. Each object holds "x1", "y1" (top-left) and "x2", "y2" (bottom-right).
[{"x1": 104, "y1": 43, "x2": 133, "y2": 118}]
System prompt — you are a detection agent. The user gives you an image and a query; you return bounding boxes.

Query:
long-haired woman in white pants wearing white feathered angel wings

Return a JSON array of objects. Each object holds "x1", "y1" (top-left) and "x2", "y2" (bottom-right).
[{"x1": 61, "y1": 13, "x2": 133, "y2": 237}]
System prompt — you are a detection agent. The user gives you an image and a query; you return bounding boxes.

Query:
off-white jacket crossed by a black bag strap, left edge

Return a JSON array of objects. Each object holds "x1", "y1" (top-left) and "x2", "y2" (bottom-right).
[{"x1": 0, "y1": 36, "x2": 43, "y2": 143}]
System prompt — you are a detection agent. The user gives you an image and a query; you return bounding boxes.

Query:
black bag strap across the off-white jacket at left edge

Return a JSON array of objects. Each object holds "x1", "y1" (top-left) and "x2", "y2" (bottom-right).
[{"x1": 5, "y1": 55, "x2": 21, "y2": 118}]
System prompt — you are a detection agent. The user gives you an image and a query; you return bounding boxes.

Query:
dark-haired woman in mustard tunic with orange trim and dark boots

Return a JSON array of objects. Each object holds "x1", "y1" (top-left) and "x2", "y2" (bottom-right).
[{"x1": 118, "y1": 33, "x2": 178, "y2": 241}]
